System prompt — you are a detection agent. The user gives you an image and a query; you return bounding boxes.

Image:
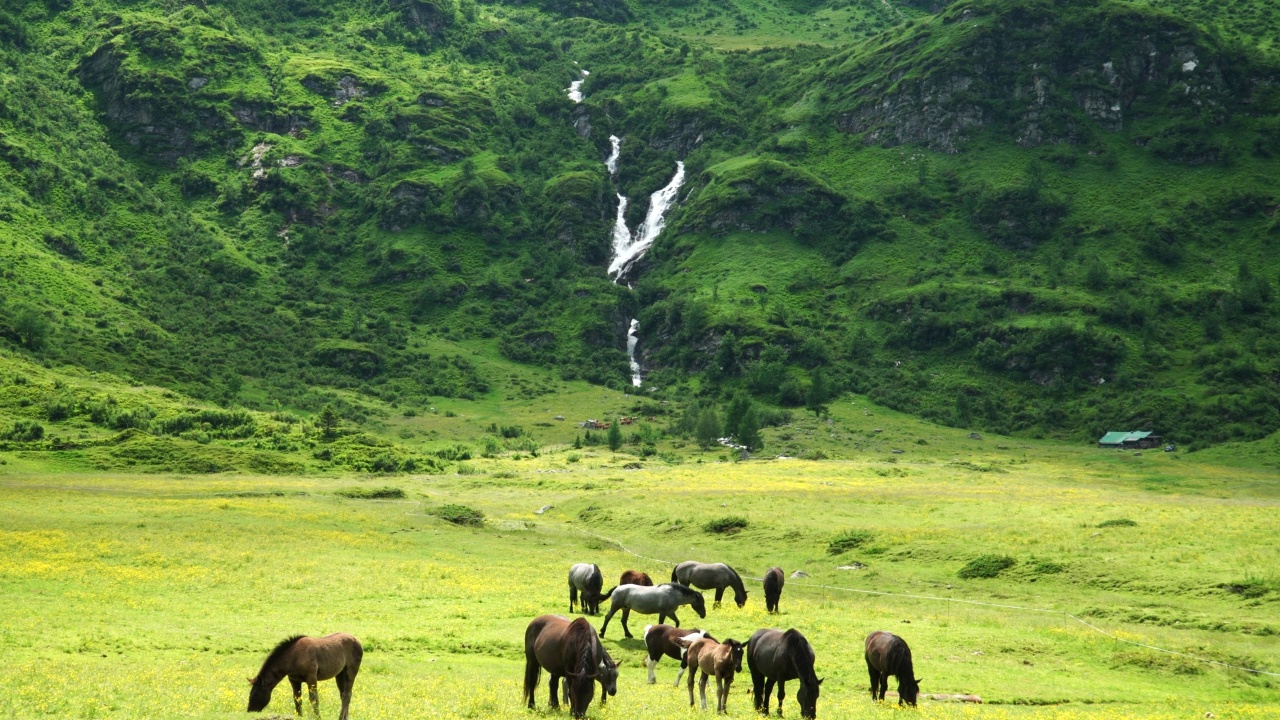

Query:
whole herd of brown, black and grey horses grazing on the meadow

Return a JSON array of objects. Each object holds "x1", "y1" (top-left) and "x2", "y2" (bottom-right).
[{"x1": 248, "y1": 561, "x2": 920, "y2": 720}]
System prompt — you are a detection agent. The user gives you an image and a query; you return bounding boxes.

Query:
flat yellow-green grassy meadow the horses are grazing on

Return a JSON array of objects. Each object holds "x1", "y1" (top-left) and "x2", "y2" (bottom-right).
[{"x1": 0, "y1": 412, "x2": 1280, "y2": 720}]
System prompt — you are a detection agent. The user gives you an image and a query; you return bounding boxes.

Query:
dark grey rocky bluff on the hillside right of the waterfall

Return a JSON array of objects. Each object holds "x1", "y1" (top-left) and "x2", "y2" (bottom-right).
[{"x1": 829, "y1": 3, "x2": 1261, "y2": 152}]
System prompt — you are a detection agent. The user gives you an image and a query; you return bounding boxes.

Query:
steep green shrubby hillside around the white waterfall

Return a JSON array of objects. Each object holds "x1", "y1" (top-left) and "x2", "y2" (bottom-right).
[{"x1": 0, "y1": 0, "x2": 1280, "y2": 448}]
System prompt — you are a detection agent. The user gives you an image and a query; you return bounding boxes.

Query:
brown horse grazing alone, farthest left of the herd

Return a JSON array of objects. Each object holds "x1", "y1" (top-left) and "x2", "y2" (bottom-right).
[{"x1": 248, "y1": 633, "x2": 365, "y2": 720}]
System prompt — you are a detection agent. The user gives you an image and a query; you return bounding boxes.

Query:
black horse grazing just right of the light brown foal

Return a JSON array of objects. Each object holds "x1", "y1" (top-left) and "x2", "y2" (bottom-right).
[{"x1": 746, "y1": 629, "x2": 822, "y2": 717}]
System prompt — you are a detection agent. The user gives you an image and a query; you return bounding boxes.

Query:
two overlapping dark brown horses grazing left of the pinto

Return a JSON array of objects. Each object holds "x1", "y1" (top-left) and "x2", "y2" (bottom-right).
[{"x1": 525, "y1": 615, "x2": 617, "y2": 717}]
